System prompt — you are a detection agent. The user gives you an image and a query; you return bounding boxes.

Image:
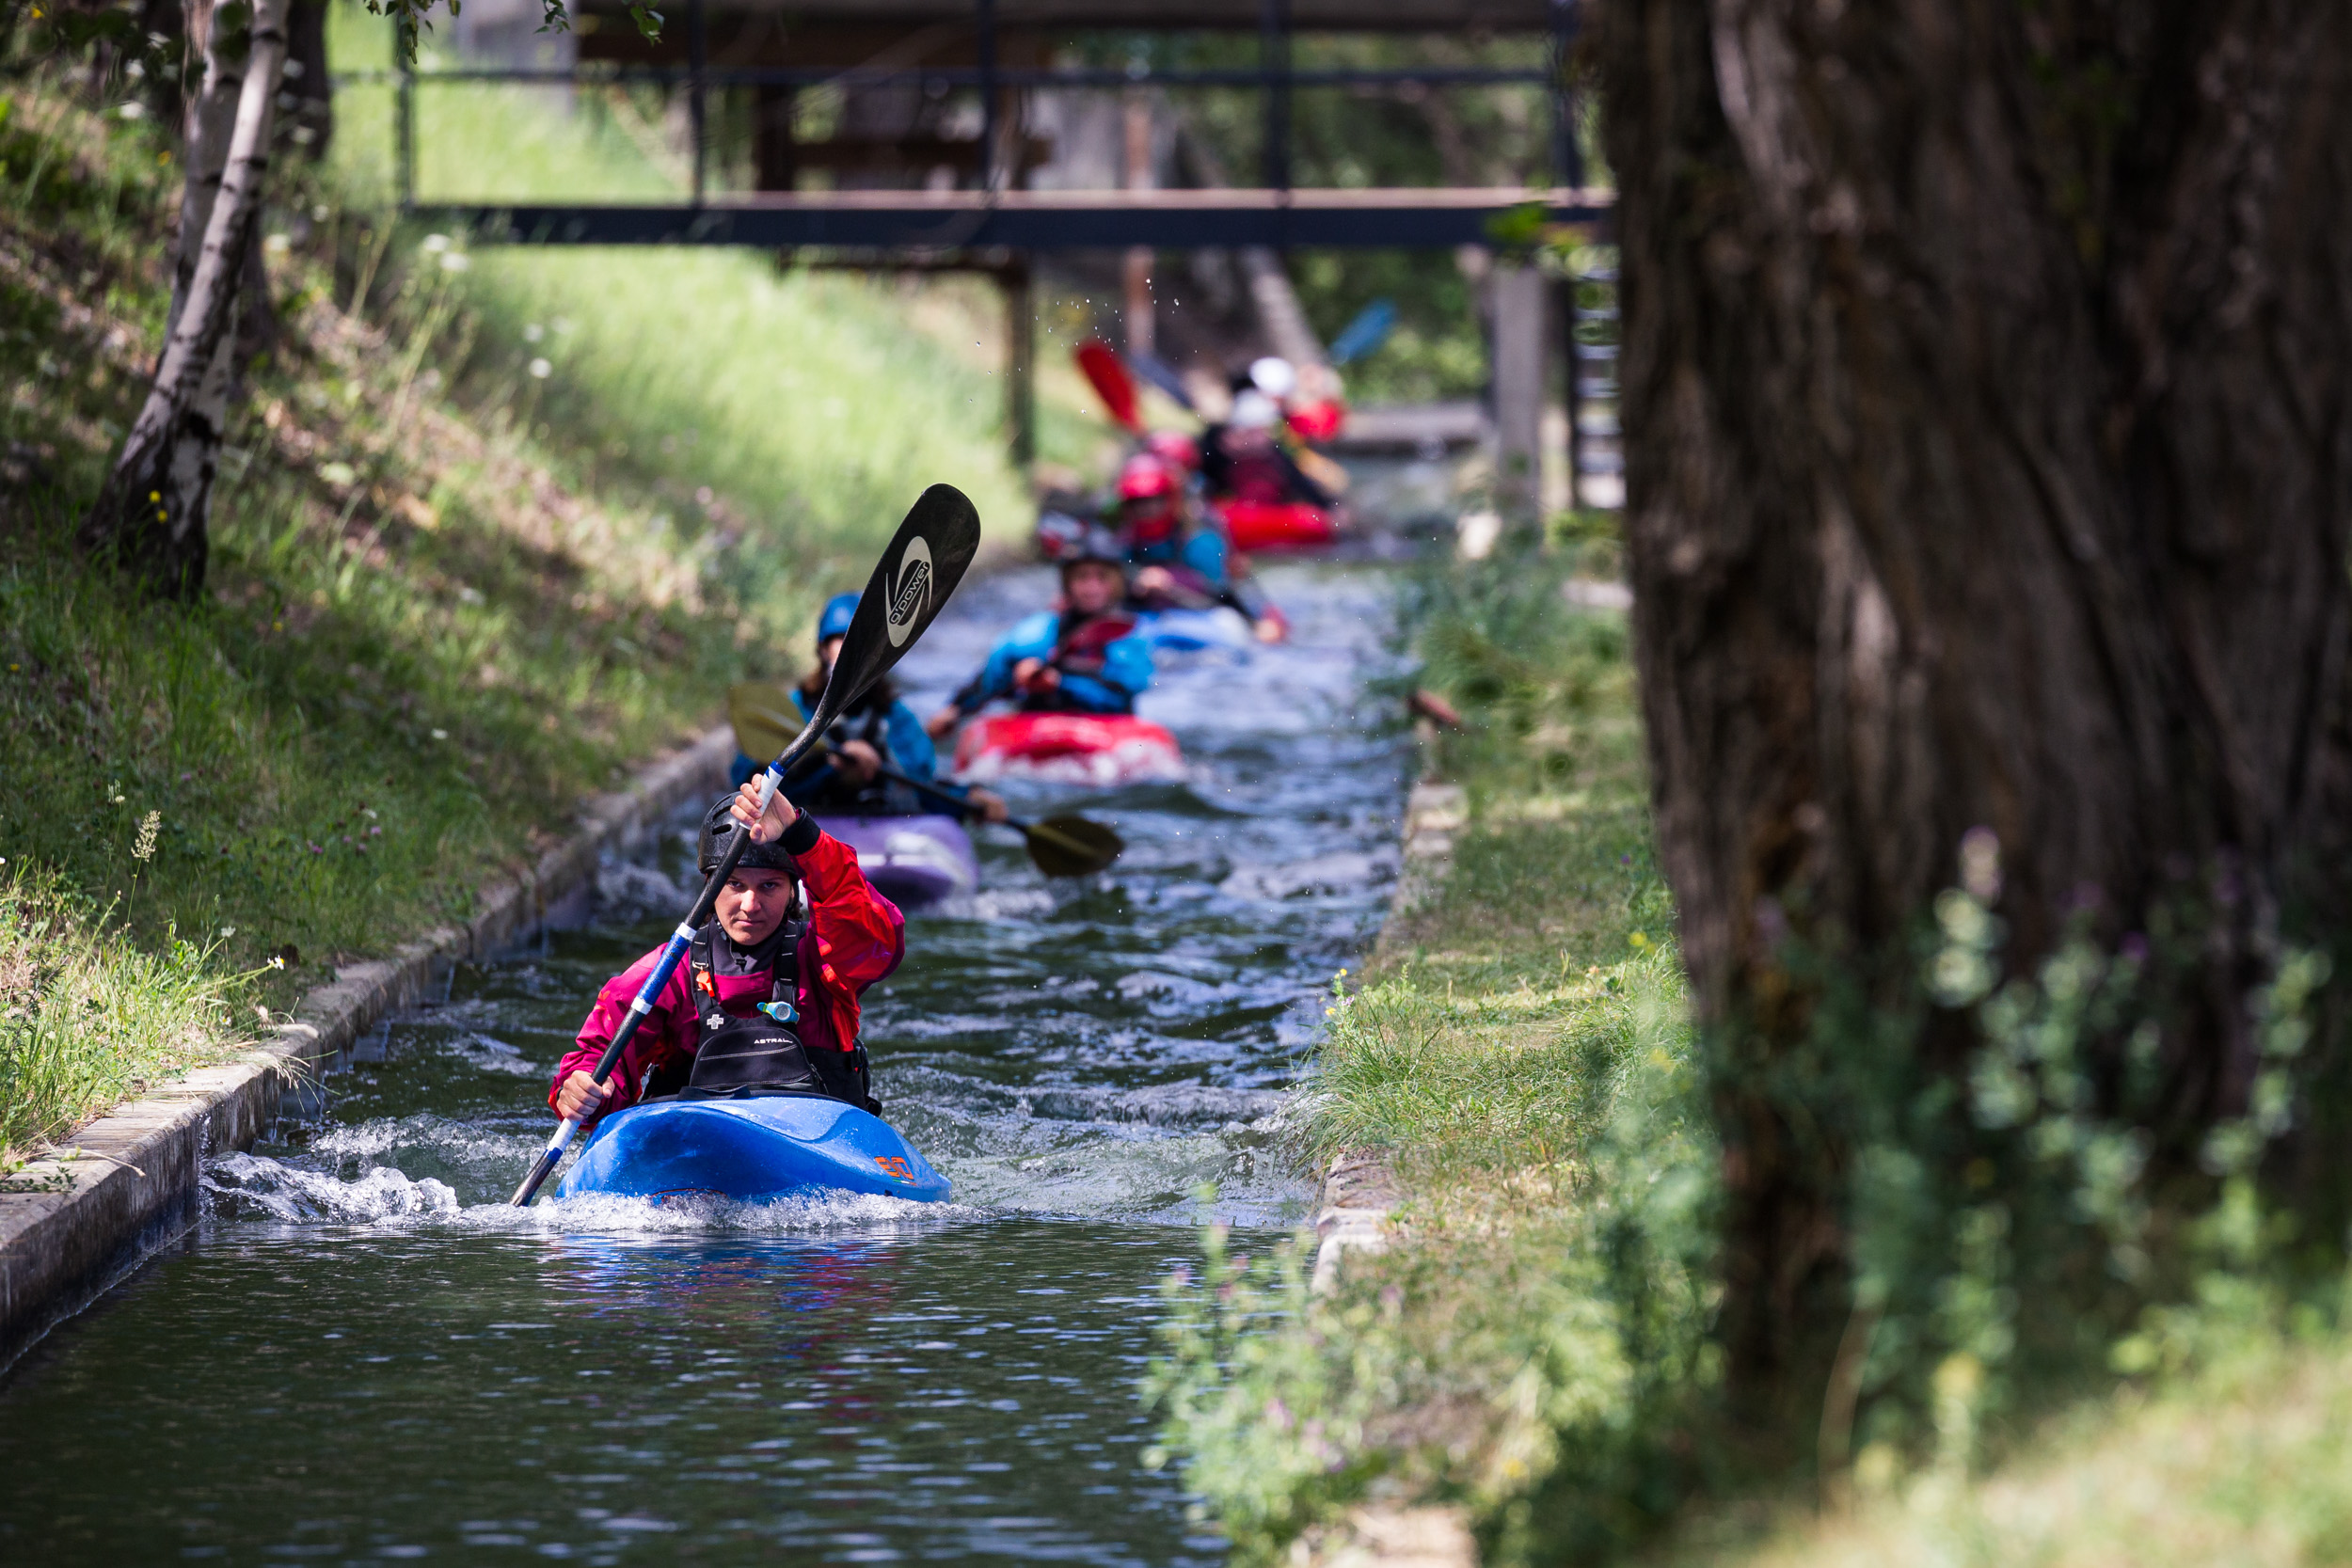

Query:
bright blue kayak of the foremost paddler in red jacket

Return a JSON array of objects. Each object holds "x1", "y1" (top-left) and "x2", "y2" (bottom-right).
[{"x1": 555, "y1": 1096, "x2": 948, "y2": 1204}]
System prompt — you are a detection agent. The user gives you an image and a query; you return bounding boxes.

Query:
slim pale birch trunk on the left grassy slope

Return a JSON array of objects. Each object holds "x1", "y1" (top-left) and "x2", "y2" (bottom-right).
[{"x1": 80, "y1": 0, "x2": 287, "y2": 597}]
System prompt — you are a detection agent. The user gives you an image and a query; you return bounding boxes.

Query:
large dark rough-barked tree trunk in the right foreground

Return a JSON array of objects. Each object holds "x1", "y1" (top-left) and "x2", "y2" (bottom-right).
[{"x1": 1597, "y1": 0, "x2": 2352, "y2": 1397}]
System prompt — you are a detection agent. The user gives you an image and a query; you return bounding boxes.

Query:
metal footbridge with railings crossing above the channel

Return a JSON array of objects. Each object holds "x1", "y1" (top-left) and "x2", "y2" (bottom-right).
[{"x1": 339, "y1": 0, "x2": 1609, "y2": 496}]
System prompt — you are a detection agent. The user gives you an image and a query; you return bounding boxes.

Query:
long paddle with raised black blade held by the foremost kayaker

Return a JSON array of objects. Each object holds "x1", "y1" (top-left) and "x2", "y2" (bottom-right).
[{"x1": 513, "y1": 484, "x2": 981, "y2": 1209}]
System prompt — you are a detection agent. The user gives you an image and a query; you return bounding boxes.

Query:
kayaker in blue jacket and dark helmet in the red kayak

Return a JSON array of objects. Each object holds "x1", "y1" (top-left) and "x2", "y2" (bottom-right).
[{"x1": 927, "y1": 529, "x2": 1152, "y2": 738}]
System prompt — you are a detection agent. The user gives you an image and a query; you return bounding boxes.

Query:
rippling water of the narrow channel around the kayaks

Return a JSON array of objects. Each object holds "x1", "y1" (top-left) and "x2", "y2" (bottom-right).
[{"x1": 0, "y1": 569, "x2": 1405, "y2": 1563}]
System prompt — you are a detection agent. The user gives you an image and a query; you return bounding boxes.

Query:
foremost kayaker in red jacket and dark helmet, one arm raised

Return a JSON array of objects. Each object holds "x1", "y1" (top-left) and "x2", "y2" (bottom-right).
[{"x1": 548, "y1": 783, "x2": 906, "y2": 1119}]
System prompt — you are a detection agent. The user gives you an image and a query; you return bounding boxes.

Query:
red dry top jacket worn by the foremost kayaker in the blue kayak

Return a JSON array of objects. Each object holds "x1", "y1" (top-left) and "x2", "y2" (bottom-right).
[{"x1": 548, "y1": 832, "x2": 906, "y2": 1121}]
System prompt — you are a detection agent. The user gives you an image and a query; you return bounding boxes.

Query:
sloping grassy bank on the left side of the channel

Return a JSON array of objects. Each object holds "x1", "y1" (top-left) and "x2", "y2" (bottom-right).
[{"x1": 0, "y1": 24, "x2": 1082, "y2": 1165}]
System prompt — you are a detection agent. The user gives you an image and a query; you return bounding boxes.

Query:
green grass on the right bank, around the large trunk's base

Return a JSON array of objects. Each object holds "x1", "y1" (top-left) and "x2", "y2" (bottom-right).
[{"x1": 1171, "y1": 543, "x2": 2352, "y2": 1568}]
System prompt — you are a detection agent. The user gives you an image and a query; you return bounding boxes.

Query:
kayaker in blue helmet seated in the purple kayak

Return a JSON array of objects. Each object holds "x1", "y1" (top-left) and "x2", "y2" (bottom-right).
[{"x1": 734, "y1": 593, "x2": 1007, "y2": 823}]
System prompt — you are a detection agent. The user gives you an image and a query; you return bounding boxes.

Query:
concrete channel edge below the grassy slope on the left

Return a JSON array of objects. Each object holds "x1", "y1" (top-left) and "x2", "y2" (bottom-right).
[{"x1": 0, "y1": 729, "x2": 737, "y2": 1369}]
